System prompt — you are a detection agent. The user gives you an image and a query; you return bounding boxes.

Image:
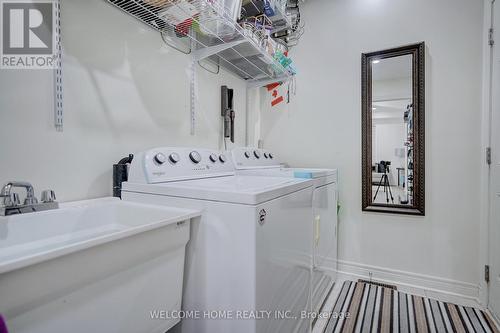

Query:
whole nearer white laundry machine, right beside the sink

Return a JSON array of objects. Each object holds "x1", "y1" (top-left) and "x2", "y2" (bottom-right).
[{"x1": 122, "y1": 148, "x2": 314, "y2": 333}]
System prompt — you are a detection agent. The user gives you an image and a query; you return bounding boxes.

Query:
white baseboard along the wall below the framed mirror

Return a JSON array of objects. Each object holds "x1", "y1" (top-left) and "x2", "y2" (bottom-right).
[{"x1": 337, "y1": 260, "x2": 483, "y2": 308}]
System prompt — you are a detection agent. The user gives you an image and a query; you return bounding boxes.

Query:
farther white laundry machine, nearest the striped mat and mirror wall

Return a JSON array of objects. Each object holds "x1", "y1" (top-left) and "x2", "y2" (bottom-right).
[{"x1": 231, "y1": 147, "x2": 338, "y2": 312}]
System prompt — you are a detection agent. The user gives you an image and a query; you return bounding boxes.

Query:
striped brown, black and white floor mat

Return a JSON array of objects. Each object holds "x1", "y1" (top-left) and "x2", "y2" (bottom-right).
[{"x1": 324, "y1": 281, "x2": 499, "y2": 333}]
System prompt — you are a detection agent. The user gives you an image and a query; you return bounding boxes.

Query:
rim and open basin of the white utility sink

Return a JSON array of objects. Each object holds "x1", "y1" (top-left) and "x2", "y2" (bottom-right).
[{"x1": 0, "y1": 198, "x2": 199, "y2": 274}]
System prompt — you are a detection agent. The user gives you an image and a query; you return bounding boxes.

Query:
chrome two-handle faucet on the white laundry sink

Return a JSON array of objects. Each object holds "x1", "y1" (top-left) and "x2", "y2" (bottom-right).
[{"x1": 0, "y1": 181, "x2": 59, "y2": 216}]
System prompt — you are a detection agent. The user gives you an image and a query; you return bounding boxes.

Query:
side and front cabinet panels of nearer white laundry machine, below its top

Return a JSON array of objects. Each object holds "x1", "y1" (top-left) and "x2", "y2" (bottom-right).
[{"x1": 123, "y1": 188, "x2": 313, "y2": 333}]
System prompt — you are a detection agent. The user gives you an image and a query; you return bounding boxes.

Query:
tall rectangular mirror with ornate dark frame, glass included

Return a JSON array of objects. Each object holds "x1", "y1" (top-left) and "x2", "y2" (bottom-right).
[{"x1": 361, "y1": 42, "x2": 425, "y2": 215}]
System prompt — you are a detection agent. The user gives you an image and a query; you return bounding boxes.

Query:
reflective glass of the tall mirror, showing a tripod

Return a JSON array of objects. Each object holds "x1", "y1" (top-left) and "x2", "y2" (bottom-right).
[{"x1": 371, "y1": 55, "x2": 414, "y2": 206}]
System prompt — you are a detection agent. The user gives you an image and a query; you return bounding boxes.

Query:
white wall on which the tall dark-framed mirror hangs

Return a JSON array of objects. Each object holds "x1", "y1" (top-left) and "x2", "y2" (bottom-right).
[{"x1": 254, "y1": 0, "x2": 483, "y2": 286}]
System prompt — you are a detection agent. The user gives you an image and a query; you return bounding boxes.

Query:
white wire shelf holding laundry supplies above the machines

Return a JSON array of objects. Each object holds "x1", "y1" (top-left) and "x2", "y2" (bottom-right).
[{"x1": 107, "y1": 0, "x2": 292, "y2": 86}]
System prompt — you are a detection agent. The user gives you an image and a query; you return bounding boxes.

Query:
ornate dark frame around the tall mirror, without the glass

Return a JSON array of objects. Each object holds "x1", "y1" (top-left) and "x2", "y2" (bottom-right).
[{"x1": 361, "y1": 42, "x2": 425, "y2": 216}]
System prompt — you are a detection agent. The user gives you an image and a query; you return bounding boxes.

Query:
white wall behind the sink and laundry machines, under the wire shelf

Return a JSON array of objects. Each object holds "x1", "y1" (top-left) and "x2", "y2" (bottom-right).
[{"x1": 0, "y1": 0, "x2": 246, "y2": 201}]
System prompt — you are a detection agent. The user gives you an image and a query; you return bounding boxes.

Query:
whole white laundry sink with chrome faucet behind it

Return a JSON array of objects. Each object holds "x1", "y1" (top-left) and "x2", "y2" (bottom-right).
[{"x1": 0, "y1": 198, "x2": 200, "y2": 332}]
